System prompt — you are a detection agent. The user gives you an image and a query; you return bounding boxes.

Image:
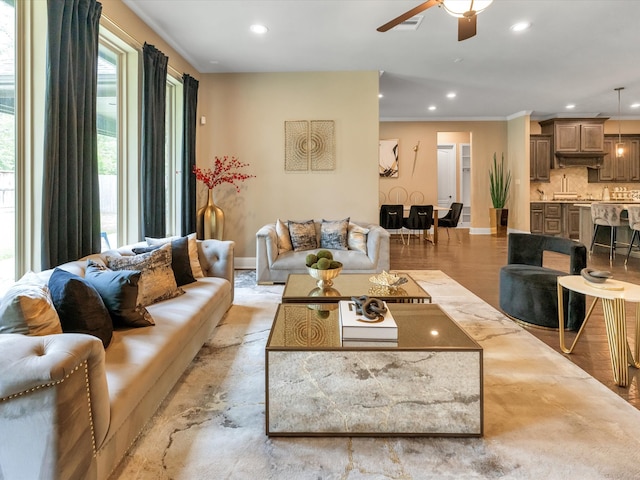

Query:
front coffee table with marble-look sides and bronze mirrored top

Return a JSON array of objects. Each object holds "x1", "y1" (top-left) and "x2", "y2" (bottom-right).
[{"x1": 266, "y1": 303, "x2": 483, "y2": 436}]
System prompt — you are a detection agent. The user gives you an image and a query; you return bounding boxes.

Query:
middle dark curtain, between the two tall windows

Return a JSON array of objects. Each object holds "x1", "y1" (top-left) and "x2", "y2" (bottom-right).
[{"x1": 141, "y1": 43, "x2": 169, "y2": 237}]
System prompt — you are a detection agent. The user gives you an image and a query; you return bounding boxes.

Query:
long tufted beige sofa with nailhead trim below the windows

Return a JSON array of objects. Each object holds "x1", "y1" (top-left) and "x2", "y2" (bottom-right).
[{"x1": 0, "y1": 239, "x2": 234, "y2": 480}]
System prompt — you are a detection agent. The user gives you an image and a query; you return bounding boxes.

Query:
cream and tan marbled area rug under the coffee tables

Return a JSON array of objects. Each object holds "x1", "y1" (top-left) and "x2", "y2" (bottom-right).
[{"x1": 112, "y1": 271, "x2": 640, "y2": 480}]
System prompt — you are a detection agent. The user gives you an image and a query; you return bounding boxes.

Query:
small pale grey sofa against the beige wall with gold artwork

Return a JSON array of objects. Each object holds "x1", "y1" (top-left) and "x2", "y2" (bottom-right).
[{"x1": 256, "y1": 219, "x2": 390, "y2": 284}]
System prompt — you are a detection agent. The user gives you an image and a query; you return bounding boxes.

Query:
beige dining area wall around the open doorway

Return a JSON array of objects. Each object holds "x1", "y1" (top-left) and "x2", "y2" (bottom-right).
[{"x1": 379, "y1": 121, "x2": 510, "y2": 233}]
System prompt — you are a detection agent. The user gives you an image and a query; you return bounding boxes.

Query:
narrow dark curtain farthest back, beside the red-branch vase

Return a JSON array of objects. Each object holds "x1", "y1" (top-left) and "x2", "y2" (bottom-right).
[{"x1": 181, "y1": 73, "x2": 198, "y2": 236}]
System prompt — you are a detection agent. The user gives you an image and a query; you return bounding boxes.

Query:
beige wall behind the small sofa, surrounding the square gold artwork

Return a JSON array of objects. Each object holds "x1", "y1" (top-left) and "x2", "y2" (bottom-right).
[{"x1": 196, "y1": 71, "x2": 379, "y2": 258}]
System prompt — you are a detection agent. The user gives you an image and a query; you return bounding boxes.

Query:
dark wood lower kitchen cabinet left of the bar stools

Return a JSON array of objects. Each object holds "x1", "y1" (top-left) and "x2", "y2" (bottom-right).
[{"x1": 530, "y1": 202, "x2": 580, "y2": 238}]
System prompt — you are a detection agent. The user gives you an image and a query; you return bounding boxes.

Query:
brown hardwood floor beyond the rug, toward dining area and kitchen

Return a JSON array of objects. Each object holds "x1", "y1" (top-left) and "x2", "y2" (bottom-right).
[{"x1": 391, "y1": 229, "x2": 640, "y2": 408}]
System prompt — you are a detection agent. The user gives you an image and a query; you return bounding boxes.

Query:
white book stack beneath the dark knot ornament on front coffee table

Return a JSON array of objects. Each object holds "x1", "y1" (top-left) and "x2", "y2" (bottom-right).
[{"x1": 338, "y1": 300, "x2": 398, "y2": 347}]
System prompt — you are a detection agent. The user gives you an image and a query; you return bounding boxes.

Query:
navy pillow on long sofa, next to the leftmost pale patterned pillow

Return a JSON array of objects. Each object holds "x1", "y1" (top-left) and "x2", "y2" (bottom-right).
[{"x1": 49, "y1": 268, "x2": 113, "y2": 348}]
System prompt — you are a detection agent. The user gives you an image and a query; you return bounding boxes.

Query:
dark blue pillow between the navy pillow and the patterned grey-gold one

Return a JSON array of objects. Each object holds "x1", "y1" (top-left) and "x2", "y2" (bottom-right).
[{"x1": 84, "y1": 259, "x2": 155, "y2": 328}]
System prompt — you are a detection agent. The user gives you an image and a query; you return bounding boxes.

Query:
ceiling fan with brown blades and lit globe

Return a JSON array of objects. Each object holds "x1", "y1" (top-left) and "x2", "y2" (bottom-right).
[{"x1": 377, "y1": 0, "x2": 493, "y2": 42}]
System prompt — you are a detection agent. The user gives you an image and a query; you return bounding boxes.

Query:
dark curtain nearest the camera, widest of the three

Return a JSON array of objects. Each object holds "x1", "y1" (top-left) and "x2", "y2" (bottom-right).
[{"x1": 42, "y1": 0, "x2": 102, "y2": 269}]
